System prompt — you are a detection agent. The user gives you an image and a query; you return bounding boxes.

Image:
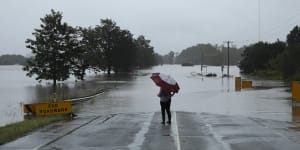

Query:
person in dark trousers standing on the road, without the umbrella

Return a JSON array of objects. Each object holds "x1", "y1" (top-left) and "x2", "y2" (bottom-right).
[{"x1": 157, "y1": 88, "x2": 175, "y2": 124}]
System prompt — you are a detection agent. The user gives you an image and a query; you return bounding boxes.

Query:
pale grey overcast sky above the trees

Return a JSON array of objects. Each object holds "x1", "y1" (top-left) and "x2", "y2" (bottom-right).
[{"x1": 0, "y1": 0, "x2": 300, "y2": 55}]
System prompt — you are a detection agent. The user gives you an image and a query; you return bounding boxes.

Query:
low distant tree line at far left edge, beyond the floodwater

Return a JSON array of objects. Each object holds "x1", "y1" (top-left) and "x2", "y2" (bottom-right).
[{"x1": 0, "y1": 55, "x2": 27, "y2": 65}]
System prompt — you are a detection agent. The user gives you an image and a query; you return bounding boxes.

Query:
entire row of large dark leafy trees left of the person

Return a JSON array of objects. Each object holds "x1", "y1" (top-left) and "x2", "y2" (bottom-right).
[{"x1": 23, "y1": 10, "x2": 158, "y2": 92}]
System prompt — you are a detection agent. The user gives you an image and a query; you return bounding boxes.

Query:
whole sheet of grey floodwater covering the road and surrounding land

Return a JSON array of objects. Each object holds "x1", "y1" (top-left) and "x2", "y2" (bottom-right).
[{"x1": 0, "y1": 65, "x2": 295, "y2": 126}]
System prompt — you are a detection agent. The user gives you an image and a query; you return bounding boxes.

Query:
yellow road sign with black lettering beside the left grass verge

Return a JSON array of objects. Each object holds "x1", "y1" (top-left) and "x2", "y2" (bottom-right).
[{"x1": 24, "y1": 101, "x2": 72, "y2": 116}]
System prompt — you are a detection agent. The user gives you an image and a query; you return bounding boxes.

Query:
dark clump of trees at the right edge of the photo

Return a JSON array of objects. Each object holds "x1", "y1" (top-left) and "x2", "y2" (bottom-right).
[{"x1": 239, "y1": 26, "x2": 300, "y2": 80}]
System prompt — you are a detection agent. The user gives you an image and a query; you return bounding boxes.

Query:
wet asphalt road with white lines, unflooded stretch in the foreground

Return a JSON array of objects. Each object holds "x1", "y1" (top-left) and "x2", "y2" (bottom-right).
[{"x1": 0, "y1": 112, "x2": 300, "y2": 150}]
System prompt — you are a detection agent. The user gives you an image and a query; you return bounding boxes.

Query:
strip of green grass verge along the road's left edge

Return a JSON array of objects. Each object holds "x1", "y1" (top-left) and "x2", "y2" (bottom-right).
[{"x1": 0, "y1": 115, "x2": 70, "y2": 145}]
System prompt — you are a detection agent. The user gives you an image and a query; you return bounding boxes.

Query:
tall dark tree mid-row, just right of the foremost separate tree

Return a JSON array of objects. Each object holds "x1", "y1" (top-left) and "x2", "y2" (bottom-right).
[{"x1": 95, "y1": 19, "x2": 136, "y2": 75}]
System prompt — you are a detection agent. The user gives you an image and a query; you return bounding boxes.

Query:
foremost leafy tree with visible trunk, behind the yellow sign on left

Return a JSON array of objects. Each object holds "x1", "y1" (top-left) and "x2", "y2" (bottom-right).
[{"x1": 23, "y1": 10, "x2": 79, "y2": 98}]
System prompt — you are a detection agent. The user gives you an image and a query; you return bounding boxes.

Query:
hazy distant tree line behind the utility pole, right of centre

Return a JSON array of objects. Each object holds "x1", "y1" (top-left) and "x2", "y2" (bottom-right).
[{"x1": 162, "y1": 44, "x2": 244, "y2": 66}]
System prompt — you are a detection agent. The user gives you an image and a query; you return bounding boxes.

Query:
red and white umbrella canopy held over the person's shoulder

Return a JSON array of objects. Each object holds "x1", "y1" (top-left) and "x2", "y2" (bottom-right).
[{"x1": 151, "y1": 73, "x2": 180, "y2": 93}]
